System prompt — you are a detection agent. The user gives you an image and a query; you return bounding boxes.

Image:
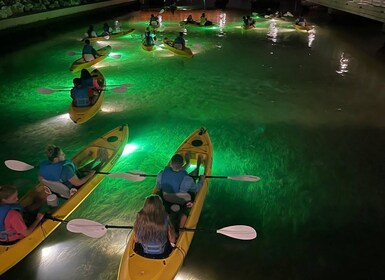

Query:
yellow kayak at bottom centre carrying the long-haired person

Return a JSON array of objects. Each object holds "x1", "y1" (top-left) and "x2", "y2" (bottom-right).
[{"x1": 118, "y1": 128, "x2": 213, "y2": 280}]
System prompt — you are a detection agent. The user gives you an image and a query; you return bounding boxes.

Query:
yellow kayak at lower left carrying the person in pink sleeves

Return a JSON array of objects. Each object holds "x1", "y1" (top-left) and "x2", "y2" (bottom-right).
[{"x1": 0, "y1": 124, "x2": 128, "y2": 275}]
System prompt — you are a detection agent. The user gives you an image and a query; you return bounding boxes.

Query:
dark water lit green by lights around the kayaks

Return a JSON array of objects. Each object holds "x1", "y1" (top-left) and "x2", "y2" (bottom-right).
[{"x1": 0, "y1": 4, "x2": 385, "y2": 280}]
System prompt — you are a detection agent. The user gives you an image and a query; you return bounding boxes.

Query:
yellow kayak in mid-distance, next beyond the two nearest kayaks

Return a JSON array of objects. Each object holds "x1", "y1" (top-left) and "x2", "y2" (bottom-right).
[{"x1": 69, "y1": 69, "x2": 106, "y2": 124}]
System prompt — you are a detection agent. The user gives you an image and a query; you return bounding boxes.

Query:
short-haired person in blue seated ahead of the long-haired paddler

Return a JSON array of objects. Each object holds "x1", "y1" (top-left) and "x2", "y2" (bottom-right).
[{"x1": 156, "y1": 153, "x2": 206, "y2": 228}]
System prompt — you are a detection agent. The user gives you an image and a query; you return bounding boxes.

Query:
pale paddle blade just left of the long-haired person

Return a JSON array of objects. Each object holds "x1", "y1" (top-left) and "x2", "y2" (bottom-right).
[{"x1": 67, "y1": 219, "x2": 107, "y2": 238}]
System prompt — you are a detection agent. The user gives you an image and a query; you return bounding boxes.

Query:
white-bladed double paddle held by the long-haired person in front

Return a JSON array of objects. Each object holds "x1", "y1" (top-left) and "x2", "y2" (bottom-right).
[{"x1": 65, "y1": 219, "x2": 257, "y2": 240}]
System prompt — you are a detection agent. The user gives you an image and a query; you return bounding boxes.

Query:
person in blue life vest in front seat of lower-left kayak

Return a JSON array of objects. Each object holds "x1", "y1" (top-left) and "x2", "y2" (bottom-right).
[{"x1": 39, "y1": 144, "x2": 103, "y2": 191}]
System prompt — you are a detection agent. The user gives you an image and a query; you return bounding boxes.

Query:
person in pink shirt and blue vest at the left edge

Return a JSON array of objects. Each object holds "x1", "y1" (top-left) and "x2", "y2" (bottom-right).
[{"x1": 0, "y1": 185, "x2": 44, "y2": 245}]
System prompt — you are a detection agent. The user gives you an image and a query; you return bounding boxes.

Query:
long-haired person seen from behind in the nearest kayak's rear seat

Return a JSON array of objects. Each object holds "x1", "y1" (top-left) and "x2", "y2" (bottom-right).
[{"x1": 134, "y1": 195, "x2": 176, "y2": 259}]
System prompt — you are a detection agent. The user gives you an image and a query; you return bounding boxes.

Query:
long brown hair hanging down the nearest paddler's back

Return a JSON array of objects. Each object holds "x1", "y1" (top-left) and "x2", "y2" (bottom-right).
[{"x1": 134, "y1": 195, "x2": 169, "y2": 244}]
